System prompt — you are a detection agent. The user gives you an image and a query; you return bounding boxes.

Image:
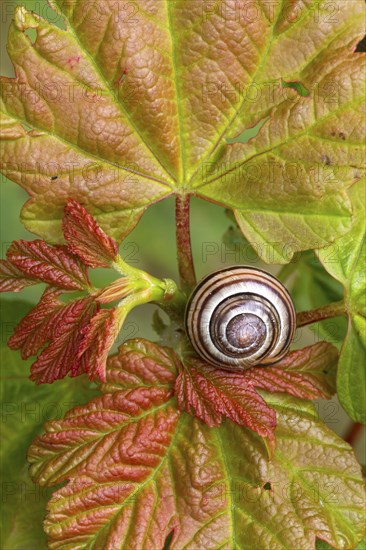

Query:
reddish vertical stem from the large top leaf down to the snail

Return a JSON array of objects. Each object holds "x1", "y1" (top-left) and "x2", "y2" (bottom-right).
[{"x1": 175, "y1": 195, "x2": 197, "y2": 293}]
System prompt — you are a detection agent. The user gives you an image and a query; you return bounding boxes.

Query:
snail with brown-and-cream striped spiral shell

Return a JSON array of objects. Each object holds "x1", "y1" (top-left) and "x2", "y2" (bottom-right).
[{"x1": 185, "y1": 266, "x2": 296, "y2": 371}]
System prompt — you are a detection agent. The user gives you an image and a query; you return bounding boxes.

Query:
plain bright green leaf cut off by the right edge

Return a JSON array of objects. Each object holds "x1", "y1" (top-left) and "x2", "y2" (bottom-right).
[{"x1": 319, "y1": 180, "x2": 366, "y2": 424}]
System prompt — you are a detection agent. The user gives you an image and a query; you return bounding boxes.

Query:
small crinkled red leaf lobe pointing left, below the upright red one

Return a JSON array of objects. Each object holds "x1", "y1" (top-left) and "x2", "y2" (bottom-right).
[{"x1": 7, "y1": 240, "x2": 89, "y2": 290}]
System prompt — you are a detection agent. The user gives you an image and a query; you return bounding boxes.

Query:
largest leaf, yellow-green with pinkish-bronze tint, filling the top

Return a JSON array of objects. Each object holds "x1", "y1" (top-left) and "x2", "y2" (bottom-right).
[{"x1": 1, "y1": 0, "x2": 365, "y2": 263}]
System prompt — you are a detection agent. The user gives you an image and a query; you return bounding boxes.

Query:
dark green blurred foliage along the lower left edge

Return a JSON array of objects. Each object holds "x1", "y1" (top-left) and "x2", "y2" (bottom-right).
[{"x1": 0, "y1": 299, "x2": 98, "y2": 550}]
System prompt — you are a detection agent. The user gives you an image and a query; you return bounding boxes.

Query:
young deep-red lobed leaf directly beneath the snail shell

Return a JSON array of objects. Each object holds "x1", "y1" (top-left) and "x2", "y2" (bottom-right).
[{"x1": 175, "y1": 342, "x2": 338, "y2": 441}]
